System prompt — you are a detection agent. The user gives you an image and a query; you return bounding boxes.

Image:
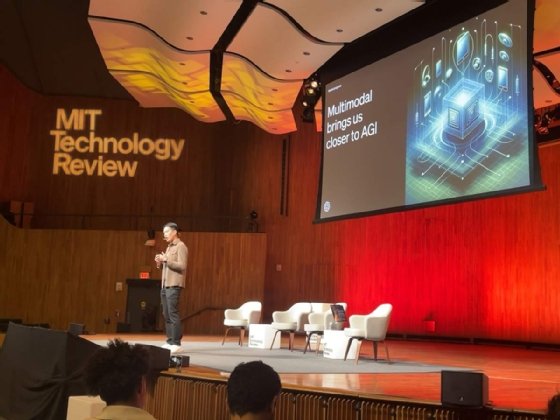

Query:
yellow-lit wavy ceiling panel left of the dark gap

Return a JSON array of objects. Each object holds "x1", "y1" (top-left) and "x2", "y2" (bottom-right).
[{"x1": 90, "y1": 18, "x2": 225, "y2": 122}]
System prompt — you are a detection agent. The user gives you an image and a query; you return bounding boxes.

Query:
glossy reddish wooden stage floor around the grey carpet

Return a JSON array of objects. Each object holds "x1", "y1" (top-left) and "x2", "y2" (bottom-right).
[{"x1": 83, "y1": 334, "x2": 560, "y2": 413}]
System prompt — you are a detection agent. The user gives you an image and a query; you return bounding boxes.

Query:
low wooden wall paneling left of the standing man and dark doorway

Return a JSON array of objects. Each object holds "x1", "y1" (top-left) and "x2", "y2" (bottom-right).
[{"x1": 0, "y1": 221, "x2": 144, "y2": 332}]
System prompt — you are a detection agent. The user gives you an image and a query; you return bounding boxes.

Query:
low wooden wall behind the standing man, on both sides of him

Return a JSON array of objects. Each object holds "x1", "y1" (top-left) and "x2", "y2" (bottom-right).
[{"x1": 0, "y1": 219, "x2": 266, "y2": 334}]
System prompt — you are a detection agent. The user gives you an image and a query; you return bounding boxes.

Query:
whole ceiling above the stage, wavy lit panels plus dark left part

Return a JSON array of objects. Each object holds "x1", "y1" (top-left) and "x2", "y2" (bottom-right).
[{"x1": 0, "y1": 0, "x2": 560, "y2": 134}]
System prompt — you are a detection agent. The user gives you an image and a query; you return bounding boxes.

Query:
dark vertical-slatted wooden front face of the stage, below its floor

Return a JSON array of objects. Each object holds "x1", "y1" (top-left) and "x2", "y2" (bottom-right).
[{"x1": 145, "y1": 373, "x2": 544, "y2": 420}]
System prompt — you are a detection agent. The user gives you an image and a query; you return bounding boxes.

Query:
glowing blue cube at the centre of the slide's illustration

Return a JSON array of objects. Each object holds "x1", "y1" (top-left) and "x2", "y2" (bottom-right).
[{"x1": 443, "y1": 79, "x2": 484, "y2": 141}]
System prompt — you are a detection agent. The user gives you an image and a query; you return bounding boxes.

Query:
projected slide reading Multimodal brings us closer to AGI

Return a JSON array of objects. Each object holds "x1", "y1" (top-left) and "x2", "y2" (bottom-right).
[{"x1": 317, "y1": 0, "x2": 533, "y2": 220}]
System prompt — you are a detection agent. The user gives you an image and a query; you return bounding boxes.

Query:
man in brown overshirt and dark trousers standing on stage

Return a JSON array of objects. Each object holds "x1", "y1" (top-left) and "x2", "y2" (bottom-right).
[{"x1": 155, "y1": 222, "x2": 189, "y2": 353}]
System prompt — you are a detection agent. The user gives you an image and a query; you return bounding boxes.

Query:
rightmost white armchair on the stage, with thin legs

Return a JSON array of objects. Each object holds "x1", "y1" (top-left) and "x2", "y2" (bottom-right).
[{"x1": 344, "y1": 303, "x2": 393, "y2": 363}]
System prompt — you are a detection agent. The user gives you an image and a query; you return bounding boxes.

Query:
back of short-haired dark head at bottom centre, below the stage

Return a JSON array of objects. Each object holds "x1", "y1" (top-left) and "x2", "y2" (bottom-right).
[{"x1": 227, "y1": 360, "x2": 282, "y2": 420}]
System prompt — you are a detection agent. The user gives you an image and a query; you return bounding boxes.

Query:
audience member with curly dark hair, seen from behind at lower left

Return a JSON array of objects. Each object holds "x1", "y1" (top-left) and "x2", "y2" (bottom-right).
[{"x1": 85, "y1": 338, "x2": 159, "y2": 420}]
